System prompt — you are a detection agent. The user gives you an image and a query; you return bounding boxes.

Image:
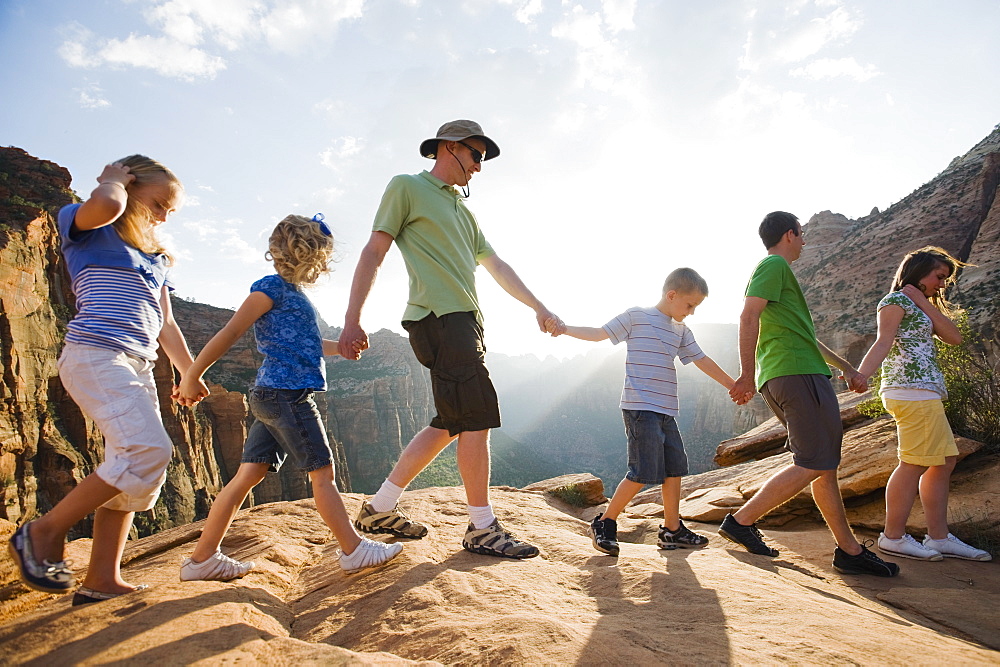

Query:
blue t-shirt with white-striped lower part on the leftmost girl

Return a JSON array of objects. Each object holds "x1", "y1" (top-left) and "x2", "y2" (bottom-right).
[{"x1": 58, "y1": 204, "x2": 171, "y2": 361}]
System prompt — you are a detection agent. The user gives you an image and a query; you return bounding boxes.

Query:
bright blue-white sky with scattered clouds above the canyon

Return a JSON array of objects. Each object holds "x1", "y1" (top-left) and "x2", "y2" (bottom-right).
[{"x1": 0, "y1": 0, "x2": 1000, "y2": 358}]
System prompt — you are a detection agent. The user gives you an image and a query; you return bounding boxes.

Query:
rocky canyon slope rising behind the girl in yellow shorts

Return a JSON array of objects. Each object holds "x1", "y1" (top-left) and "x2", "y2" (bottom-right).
[{"x1": 792, "y1": 126, "x2": 1000, "y2": 363}]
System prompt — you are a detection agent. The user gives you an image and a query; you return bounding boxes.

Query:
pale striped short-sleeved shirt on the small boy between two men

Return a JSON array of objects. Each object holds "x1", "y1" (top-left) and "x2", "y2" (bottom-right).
[{"x1": 603, "y1": 308, "x2": 705, "y2": 417}]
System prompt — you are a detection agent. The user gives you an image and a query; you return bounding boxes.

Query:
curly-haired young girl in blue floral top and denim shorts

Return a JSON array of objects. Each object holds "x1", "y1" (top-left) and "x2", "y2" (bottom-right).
[{"x1": 178, "y1": 215, "x2": 403, "y2": 581}]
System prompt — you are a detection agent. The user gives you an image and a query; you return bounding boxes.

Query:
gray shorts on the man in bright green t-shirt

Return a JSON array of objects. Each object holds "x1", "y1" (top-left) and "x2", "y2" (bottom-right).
[{"x1": 760, "y1": 374, "x2": 844, "y2": 470}]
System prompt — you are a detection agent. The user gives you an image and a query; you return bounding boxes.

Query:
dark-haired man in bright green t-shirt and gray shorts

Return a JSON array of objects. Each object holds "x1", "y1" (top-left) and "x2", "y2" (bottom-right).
[{"x1": 719, "y1": 211, "x2": 899, "y2": 577}]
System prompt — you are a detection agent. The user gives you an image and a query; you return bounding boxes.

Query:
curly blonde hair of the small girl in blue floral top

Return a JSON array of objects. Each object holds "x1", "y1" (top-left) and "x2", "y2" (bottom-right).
[{"x1": 264, "y1": 215, "x2": 334, "y2": 286}]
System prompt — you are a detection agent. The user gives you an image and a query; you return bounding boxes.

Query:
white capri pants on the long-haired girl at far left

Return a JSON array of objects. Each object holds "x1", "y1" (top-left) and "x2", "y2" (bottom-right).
[{"x1": 59, "y1": 343, "x2": 173, "y2": 512}]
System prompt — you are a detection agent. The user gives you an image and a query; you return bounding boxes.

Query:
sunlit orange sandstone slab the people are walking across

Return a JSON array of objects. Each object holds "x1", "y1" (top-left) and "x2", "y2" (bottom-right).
[{"x1": 0, "y1": 488, "x2": 1000, "y2": 665}]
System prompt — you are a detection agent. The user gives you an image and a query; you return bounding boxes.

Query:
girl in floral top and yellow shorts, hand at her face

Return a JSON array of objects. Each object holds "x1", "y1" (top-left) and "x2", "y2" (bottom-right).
[{"x1": 858, "y1": 246, "x2": 992, "y2": 561}]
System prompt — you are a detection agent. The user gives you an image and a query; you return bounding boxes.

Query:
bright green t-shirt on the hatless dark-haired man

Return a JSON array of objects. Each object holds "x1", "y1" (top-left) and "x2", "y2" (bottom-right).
[{"x1": 746, "y1": 255, "x2": 831, "y2": 389}]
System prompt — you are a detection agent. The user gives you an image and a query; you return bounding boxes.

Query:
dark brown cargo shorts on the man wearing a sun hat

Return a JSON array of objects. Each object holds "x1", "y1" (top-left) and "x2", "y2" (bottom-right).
[{"x1": 403, "y1": 312, "x2": 500, "y2": 435}]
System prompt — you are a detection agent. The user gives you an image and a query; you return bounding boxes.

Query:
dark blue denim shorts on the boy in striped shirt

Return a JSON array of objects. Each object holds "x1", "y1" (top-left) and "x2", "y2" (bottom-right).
[{"x1": 622, "y1": 410, "x2": 688, "y2": 484}]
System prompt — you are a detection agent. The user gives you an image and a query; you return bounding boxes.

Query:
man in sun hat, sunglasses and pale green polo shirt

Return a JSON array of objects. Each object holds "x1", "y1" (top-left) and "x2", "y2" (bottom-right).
[{"x1": 340, "y1": 120, "x2": 561, "y2": 558}]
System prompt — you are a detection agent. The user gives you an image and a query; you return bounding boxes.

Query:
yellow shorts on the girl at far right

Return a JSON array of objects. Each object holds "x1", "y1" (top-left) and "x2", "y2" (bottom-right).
[{"x1": 882, "y1": 396, "x2": 958, "y2": 466}]
